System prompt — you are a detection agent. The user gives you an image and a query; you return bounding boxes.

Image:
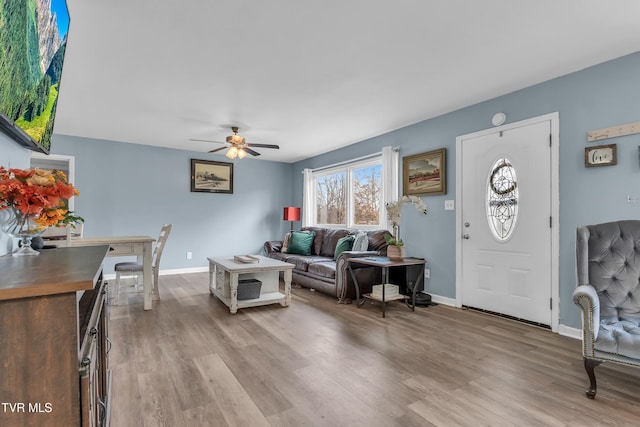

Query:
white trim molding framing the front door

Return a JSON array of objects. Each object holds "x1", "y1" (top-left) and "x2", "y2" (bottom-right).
[{"x1": 455, "y1": 112, "x2": 560, "y2": 332}]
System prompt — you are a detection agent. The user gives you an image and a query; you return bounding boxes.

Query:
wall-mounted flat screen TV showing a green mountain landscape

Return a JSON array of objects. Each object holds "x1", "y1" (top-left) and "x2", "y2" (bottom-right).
[{"x1": 0, "y1": 0, "x2": 69, "y2": 154}]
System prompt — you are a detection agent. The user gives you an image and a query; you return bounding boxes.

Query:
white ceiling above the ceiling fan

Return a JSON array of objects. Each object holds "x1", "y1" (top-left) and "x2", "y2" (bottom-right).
[{"x1": 54, "y1": 0, "x2": 640, "y2": 162}]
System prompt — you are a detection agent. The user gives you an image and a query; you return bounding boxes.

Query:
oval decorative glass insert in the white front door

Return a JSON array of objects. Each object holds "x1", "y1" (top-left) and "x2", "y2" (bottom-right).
[{"x1": 487, "y1": 157, "x2": 518, "y2": 242}]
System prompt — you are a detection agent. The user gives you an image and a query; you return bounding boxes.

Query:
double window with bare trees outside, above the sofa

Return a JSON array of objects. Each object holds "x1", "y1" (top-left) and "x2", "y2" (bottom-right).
[{"x1": 313, "y1": 157, "x2": 386, "y2": 229}]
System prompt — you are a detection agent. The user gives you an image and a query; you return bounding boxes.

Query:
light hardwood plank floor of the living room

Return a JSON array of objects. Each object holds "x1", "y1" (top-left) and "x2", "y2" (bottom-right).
[{"x1": 109, "y1": 273, "x2": 640, "y2": 427}]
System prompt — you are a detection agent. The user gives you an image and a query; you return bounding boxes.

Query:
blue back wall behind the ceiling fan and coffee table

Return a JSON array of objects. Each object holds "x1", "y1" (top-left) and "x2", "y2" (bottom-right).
[{"x1": 52, "y1": 135, "x2": 292, "y2": 273}]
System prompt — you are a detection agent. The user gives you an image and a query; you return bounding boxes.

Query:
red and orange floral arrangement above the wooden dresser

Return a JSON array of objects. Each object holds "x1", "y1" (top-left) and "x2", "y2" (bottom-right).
[{"x1": 0, "y1": 166, "x2": 84, "y2": 228}]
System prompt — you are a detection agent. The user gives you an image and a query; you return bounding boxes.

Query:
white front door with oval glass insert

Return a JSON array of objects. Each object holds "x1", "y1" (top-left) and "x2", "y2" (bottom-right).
[{"x1": 460, "y1": 121, "x2": 552, "y2": 325}]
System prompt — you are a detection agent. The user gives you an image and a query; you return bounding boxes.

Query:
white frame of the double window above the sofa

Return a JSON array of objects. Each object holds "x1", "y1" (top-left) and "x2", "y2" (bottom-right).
[{"x1": 312, "y1": 156, "x2": 387, "y2": 230}]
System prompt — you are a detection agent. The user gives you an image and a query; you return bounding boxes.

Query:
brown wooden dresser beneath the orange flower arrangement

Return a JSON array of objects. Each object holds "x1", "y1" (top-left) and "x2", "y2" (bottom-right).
[{"x1": 0, "y1": 246, "x2": 111, "y2": 427}]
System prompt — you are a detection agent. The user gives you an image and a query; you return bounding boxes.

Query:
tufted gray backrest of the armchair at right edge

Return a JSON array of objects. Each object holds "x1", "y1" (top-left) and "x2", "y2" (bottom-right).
[{"x1": 576, "y1": 220, "x2": 640, "y2": 320}]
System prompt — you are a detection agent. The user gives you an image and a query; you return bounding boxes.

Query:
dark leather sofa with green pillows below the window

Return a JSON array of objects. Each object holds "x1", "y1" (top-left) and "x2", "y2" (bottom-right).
[{"x1": 264, "y1": 227, "x2": 390, "y2": 303}]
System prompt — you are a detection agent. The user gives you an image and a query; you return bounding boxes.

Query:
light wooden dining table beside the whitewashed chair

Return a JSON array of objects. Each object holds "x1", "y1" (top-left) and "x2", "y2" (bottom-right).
[{"x1": 70, "y1": 236, "x2": 160, "y2": 310}]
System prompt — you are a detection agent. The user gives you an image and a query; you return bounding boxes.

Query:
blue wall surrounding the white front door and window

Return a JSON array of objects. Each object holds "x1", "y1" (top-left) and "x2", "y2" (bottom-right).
[{"x1": 293, "y1": 53, "x2": 640, "y2": 328}]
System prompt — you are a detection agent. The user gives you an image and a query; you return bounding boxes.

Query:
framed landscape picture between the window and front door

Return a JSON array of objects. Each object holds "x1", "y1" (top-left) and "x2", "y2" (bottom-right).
[{"x1": 402, "y1": 148, "x2": 447, "y2": 196}]
